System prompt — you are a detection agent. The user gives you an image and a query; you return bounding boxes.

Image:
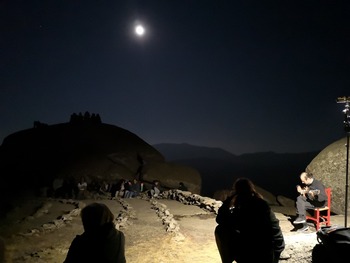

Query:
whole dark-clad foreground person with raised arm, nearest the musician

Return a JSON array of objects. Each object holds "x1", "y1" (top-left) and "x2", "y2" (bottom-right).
[{"x1": 214, "y1": 178, "x2": 285, "y2": 263}]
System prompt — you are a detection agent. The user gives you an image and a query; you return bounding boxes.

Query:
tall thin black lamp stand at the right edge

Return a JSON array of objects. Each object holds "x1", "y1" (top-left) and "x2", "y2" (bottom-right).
[{"x1": 337, "y1": 96, "x2": 350, "y2": 227}]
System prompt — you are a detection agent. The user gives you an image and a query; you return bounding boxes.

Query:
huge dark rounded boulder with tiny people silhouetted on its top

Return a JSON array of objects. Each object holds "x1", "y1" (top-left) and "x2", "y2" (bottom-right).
[{"x1": 0, "y1": 116, "x2": 201, "y2": 199}]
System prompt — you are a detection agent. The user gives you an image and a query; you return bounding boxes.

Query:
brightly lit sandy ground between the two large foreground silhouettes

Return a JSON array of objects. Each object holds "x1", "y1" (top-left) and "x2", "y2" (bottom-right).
[{"x1": 124, "y1": 199, "x2": 221, "y2": 263}]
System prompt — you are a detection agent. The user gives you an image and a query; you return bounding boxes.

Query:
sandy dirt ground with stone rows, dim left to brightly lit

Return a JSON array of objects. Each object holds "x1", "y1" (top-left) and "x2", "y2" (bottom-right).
[{"x1": 0, "y1": 198, "x2": 342, "y2": 263}]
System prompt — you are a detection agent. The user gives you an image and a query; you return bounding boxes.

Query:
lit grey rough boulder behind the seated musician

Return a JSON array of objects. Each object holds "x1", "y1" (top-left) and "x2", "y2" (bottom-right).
[{"x1": 306, "y1": 137, "x2": 349, "y2": 214}]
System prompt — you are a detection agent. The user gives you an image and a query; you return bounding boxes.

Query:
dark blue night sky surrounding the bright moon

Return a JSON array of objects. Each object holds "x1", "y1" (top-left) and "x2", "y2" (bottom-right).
[{"x1": 0, "y1": 0, "x2": 350, "y2": 154}]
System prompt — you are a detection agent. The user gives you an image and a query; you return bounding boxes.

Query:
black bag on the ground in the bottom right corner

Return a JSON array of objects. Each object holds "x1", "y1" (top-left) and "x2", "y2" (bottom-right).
[{"x1": 312, "y1": 226, "x2": 350, "y2": 263}]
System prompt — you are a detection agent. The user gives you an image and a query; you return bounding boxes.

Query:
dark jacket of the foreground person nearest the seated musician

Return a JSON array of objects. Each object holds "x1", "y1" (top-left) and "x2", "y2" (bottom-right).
[{"x1": 216, "y1": 196, "x2": 285, "y2": 262}]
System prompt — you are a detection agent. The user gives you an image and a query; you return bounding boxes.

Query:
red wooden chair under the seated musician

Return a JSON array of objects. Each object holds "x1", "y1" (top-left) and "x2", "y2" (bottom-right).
[{"x1": 306, "y1": 188, "x2": 331, "y2": 231}]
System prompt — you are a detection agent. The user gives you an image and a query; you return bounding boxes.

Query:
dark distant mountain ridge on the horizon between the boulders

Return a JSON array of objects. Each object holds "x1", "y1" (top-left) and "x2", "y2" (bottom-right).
[{"x1": 152, "y1": 143, "x2": 319, "y2": 197}]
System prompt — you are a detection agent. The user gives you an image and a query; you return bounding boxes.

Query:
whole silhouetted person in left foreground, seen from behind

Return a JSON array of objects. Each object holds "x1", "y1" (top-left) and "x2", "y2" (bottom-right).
[{"x1": 64, "y1": 203, "x2": 126, "y2": 263}]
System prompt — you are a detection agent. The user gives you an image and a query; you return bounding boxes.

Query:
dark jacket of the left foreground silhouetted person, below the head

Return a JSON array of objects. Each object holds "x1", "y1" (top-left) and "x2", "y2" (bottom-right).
[{"x1": 64, "y1": 223, "x2": 126, "y2": 263}]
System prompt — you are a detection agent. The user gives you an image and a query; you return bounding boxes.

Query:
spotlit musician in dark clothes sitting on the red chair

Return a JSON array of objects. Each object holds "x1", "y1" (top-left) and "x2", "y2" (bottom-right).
[{"x1": 293, "y1": 172, "x2": 328, "y2": 232}]
